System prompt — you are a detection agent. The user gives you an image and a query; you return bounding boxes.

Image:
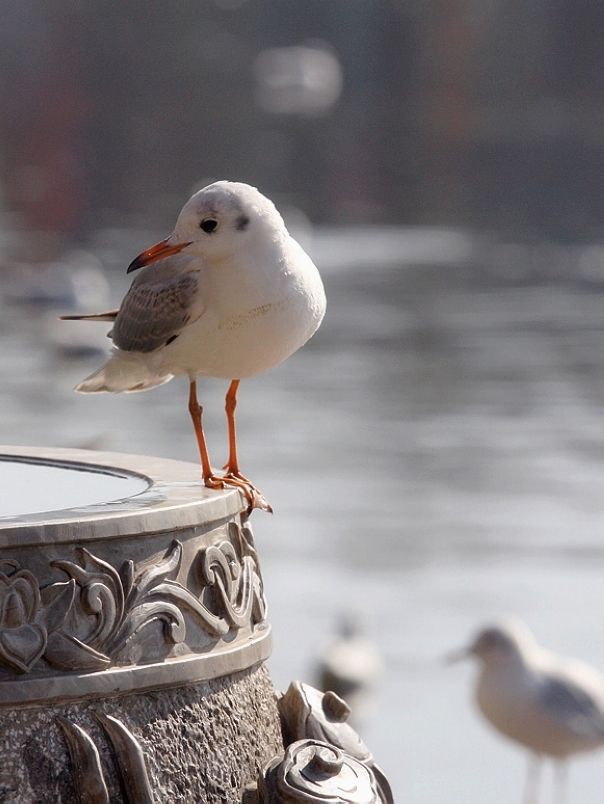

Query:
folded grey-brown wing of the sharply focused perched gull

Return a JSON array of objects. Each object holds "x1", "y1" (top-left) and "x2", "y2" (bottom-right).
[{"x1": 111, "y1": 274, "x2": 199, "y2": 352}]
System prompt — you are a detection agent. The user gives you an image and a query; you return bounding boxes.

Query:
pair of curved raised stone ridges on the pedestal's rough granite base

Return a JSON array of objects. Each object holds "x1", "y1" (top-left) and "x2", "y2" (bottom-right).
[{"x1": 56, "y1": 712, "x2": 153, "y2": 804}]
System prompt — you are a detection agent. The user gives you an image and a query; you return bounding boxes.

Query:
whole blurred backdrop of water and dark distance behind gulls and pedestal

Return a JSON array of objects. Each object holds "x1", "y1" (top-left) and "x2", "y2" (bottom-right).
[{"x1": 0, "y1": 0, "x2": 604, "y2": 804}]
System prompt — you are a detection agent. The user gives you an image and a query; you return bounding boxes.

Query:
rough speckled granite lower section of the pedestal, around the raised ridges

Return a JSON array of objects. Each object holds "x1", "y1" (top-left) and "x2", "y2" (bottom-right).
[{"x1": 0, "y1": 664, "x2": 283, "y2": 804}]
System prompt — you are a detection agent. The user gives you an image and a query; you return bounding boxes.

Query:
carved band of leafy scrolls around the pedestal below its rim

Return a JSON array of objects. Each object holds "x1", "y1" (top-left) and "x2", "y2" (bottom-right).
[{"x1": 0, "y1": 523, "x2": 266, "y2": 673}]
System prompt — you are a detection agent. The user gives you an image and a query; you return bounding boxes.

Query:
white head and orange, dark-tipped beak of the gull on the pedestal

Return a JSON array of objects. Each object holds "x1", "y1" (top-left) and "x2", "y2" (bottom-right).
[{"x1": 128, "y1": 181, "x2": 287, "y2": 273}]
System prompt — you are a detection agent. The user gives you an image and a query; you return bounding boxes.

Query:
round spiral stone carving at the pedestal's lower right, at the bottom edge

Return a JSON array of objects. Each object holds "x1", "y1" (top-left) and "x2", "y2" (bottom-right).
[{"x1": 254, "y1": 740, "x2": 380, "y2": 804}]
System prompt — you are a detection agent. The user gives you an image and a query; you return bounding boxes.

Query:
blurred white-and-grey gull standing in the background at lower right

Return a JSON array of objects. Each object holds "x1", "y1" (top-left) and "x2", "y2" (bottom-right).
[{"x1": 448, "y1": 621, "x2": 604, "y2": 804}]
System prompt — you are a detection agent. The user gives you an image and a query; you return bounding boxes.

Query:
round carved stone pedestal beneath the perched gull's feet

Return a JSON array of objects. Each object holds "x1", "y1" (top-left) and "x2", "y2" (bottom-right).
[{"x1": 0, "y1": 447, "x2": 283, "y2": 804}]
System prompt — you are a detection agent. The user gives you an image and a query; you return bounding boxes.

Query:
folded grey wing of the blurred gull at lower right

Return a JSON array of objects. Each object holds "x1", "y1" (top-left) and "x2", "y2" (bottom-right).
[{"x1": 538, "y1": 676, "x2": 604, "y2": 738}]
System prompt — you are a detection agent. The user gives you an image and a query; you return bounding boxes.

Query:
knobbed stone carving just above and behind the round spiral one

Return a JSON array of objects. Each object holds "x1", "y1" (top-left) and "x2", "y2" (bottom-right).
[{"x1": 277, "y1": 681, "x2": 394, "y2": 804}]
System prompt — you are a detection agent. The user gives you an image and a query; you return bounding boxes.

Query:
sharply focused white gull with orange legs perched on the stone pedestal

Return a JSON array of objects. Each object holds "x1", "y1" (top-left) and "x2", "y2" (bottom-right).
[{"x1": 63, "y1": 181, "x2": 326, "y2": 511}]
